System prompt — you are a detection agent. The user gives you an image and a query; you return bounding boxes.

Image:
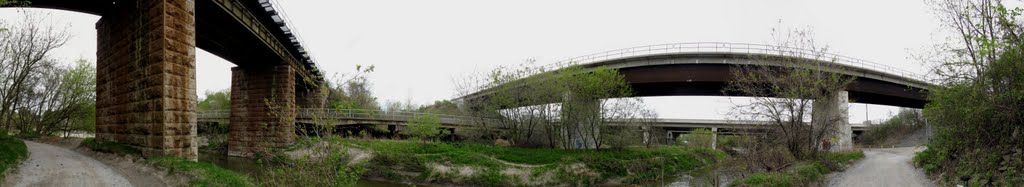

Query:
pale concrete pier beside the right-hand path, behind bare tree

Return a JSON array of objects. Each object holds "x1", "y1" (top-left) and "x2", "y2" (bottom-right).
[{"x1": 811, "y1": 91, "x2": 853, "y2": 151}]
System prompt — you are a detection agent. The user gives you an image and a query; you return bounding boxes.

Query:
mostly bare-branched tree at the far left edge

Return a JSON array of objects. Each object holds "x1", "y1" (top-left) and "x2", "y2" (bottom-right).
[{"x1": 0, "y1": 12, "x2": 71, "y2": 133}]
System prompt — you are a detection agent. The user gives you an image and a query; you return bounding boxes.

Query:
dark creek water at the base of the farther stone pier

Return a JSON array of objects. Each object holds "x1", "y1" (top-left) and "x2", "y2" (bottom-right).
[{"x1": 199, "y1": 152, "x2": 413, "y2": 187}]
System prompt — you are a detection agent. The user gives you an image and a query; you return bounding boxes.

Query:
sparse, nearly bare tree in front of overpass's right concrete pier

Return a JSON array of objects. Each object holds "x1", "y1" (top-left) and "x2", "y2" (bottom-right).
[{"x1": 725, "y1": 26, "x2": 853, "y2": 159}]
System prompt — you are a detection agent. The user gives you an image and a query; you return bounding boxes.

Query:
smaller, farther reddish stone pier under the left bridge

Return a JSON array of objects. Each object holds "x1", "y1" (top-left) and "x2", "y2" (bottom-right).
[{"x1": 227, "y1": 65, "x2": 296, "y2": 156}]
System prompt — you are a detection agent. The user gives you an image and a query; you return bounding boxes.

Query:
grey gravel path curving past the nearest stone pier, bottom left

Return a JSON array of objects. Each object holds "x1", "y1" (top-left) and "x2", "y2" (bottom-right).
[{"x1": 0, "y1": 141, "x2": 132, "y2": 186}]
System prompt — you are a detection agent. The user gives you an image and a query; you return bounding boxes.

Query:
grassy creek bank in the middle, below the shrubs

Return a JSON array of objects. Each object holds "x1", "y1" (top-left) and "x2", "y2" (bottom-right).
[{"x1": 333, "y1": 139, "x2": 725, "y2": 186}]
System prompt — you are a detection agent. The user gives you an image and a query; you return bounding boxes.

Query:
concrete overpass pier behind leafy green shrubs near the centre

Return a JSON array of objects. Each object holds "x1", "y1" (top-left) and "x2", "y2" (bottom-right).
[{"x1": 561, "y1": 96, "x2": 601, "y2": 149}]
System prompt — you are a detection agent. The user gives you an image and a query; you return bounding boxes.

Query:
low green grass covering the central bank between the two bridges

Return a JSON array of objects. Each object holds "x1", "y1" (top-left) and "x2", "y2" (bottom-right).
[{"x1": 332, "y1": 136, "x2": 725, "y2": 186}]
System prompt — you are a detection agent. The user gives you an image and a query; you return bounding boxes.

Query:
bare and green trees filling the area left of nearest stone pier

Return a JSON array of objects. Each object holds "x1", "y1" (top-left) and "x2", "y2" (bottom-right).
[{"x1": 0, "y1": 11, "x2": 96, "y2": 136}]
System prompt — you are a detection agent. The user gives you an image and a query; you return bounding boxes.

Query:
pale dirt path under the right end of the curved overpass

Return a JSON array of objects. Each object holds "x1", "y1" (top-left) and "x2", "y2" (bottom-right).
[{"x1": 828, "y1": 147, "x2": 935, "y2": 187}]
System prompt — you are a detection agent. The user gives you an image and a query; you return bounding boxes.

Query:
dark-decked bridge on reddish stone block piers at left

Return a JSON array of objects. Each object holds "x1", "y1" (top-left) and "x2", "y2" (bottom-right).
[{"x1": 4, "y1": 0, "x2": 323, "y2": 160}]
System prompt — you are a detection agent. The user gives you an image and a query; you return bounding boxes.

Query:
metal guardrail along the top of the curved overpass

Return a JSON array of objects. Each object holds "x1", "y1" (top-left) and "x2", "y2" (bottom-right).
[{"x1": 480, "y1": 42, "x2": 926, "y2": 90}]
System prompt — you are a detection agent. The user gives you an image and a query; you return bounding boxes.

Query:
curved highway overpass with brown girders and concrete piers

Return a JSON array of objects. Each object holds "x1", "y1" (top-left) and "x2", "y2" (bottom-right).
[{"x1": 458, "y1": 42, "x2": 934, "y2": 149}]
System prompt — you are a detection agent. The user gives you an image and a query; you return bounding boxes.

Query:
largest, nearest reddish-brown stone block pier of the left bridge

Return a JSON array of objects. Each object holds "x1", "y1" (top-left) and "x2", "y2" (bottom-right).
[{"x1": 96, "y1": 0, "x2": 198, "y2": 160}]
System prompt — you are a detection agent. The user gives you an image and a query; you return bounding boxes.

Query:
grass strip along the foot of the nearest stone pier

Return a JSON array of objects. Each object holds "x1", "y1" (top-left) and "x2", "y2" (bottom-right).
[{"x1": 79, "y1": 138, "x2": 255, "y2": 186}]
